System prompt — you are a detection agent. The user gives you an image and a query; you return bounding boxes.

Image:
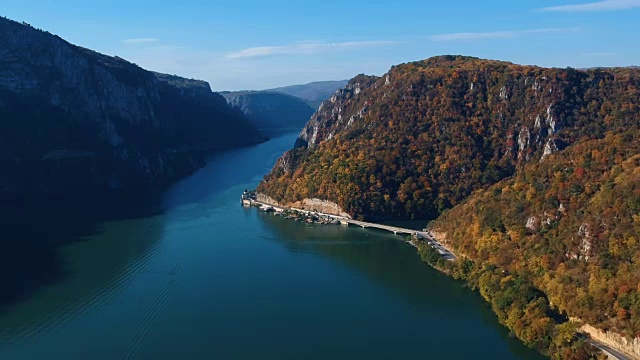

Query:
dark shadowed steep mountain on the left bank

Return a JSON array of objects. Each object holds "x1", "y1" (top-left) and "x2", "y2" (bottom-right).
[{"x1": 0, "y1": 18, "x2": 264, "y2": 196}]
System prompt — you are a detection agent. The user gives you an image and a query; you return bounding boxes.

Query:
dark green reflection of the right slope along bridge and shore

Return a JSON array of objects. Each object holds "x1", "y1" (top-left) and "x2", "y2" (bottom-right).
[{"x1": 255, "y1": 210, "x2": 544, "y2": 359}]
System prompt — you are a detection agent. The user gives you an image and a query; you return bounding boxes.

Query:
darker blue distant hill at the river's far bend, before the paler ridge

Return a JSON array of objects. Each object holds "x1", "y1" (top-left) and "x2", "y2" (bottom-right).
[{"x1": 221, "y1": 91, "x2": 315, "y2": 135}]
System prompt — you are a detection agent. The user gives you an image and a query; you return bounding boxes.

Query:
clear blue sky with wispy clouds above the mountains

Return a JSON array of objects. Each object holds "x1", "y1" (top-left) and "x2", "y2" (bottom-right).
[{"x1": 5, "y1": 0, "x2": 640, "y2": 90}]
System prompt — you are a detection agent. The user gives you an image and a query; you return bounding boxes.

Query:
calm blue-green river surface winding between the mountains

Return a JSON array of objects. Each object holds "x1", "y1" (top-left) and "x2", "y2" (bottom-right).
[{"x1": 0, "y1": 135, "x2": 540, "y2": 359}]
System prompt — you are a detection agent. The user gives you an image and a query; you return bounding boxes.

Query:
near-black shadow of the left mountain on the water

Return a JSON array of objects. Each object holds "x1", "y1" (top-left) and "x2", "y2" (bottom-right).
[{"x1": 0, "y1": 194, "x2": 162, "y2": 315}]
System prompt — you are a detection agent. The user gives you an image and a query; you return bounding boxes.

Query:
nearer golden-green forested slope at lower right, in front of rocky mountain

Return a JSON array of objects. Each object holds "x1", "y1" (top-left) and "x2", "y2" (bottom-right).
[{"x1": 432, "y1": 130, "x2": 640, "y2": 358}]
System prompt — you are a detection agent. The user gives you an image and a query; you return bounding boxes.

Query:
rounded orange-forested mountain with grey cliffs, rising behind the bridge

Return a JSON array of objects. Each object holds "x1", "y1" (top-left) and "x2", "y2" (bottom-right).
[{"x1": 259, "y1": 56, "x2": 640, "y2": 219}]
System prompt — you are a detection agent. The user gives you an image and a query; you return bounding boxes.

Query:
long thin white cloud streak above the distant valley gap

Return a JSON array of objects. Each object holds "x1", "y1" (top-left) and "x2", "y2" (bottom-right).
[{"x1": 226, "y1": 40, "x2": 397, "y2": 59}]
